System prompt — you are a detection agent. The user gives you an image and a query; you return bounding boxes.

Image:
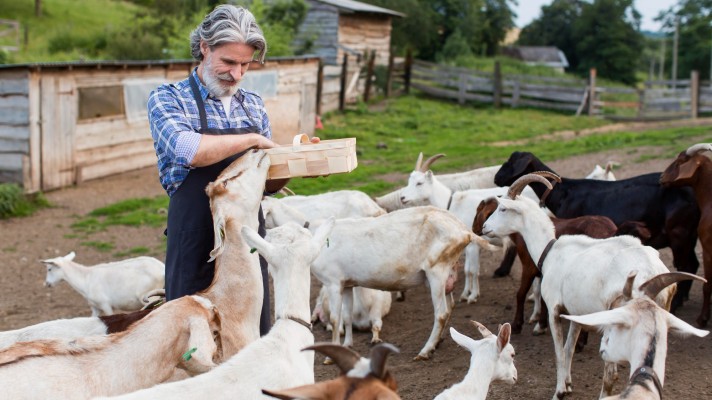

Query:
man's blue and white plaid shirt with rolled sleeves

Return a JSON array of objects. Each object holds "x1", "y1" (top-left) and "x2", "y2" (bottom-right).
[{"x1": 148, "y1": 68, "x2": 272, "y2": 196}]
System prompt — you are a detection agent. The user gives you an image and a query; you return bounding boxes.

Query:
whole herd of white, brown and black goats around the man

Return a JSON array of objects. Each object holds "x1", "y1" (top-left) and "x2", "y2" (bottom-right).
[{"x1": 0, "y1": 143, "x2": 712, "y2": 400}]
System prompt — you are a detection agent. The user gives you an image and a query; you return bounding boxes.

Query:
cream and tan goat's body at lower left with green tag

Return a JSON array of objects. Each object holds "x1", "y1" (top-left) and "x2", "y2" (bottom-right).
[{"x1": 0, "y1": 296, "x2": 220, "y2": 400}]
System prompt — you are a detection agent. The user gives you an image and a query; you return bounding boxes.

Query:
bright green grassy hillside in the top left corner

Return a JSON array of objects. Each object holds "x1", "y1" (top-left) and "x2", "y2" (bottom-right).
[{"x1": 0, "y1": 0, "x2": 139, "y2": 63}]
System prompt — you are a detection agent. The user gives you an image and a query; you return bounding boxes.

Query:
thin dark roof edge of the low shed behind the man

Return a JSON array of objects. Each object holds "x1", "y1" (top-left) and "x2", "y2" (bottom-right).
[{"x1": 0, "y1": 55, "x2": 319, "y2": 70}]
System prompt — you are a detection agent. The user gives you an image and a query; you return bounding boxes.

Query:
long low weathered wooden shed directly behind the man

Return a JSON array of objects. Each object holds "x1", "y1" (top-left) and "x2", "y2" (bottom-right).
[{"x1": 0, "y1": 56, "x2": 319, "y2": 192}]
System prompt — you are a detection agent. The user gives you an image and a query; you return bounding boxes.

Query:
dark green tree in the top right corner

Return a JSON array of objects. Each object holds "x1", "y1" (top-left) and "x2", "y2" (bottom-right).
[{"x1": 656, "y1": 0, "x2": 712, "y2": 79}]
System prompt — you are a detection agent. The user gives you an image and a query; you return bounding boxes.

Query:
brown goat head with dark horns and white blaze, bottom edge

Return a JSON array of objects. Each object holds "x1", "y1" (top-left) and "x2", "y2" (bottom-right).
[{"x1": 262, "y1": 343, "x2": 400, "y2": 400}]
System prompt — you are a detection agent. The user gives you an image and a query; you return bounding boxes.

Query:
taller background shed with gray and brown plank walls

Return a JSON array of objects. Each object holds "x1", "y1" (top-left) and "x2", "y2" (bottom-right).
[{"x1": 294, "y1": 0, "x2": 405, "y2": 65}]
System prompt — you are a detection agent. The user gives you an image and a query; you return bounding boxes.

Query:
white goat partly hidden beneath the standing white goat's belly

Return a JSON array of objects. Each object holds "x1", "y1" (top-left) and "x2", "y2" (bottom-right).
[{"x1": 312, "y1": 286, "x2": 393, "y2": 343}]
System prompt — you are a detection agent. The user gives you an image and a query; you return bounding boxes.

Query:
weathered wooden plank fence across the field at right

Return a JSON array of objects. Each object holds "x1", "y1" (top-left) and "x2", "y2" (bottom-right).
[{"x1": 406, "y1": 60, "x2": 712, "y2": 120}]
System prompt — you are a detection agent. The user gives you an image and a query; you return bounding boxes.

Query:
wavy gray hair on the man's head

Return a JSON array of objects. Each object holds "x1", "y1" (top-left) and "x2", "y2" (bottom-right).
[{"x1": 190, "y1": 4, "x2": 267, "y2": 62}]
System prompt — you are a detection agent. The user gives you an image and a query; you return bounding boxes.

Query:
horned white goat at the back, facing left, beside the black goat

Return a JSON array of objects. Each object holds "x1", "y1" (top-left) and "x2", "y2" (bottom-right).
[{"x1": 401, "y1": 166, "x2": 539, "y2": 304}]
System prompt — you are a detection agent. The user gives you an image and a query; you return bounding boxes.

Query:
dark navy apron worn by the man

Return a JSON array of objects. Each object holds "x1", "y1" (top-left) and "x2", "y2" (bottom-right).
[{"x1": 166, "y1": 74, "x2": 271, "y2": 335}]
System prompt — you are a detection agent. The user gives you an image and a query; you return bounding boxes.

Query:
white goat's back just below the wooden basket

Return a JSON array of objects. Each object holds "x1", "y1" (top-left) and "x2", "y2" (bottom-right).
[{"x1": 262, "y1": 190, "x2": 386, "y2": 229}]
